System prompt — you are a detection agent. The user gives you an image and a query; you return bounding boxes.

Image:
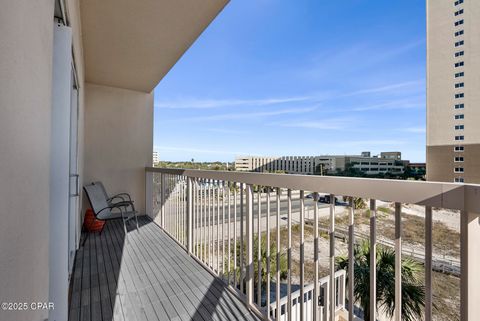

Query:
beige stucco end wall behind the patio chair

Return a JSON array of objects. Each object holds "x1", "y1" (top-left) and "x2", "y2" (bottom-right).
[{"x1": 82, "y1": 83, "x2": 153, "y2": 214}]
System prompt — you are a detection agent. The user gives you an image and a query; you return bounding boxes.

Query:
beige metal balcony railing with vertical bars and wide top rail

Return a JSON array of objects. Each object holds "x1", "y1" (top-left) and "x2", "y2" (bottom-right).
[{"x1": 145, "y1": 168, "x2": 480, "y2": 321}]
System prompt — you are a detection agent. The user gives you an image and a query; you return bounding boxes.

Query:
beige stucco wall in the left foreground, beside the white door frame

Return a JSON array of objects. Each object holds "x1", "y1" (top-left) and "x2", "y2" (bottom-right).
[{"x1": 0, "y1": 0, "x2": 54, "y2": 321}]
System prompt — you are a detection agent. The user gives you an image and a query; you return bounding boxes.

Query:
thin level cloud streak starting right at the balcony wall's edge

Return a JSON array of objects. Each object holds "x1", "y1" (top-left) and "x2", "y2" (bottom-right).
[{"x1": 155, "y1": 96, "x2": 312, "y2": 109}]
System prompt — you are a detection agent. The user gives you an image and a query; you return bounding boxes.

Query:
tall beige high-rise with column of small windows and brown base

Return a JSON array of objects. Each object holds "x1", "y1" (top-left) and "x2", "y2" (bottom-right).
[{"x1": 427, "y1": 0, "x2": 480, "y2": 183}]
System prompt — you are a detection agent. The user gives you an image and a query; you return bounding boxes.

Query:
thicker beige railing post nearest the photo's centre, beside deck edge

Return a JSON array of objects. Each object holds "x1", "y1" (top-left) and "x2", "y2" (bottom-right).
[{"x1": 246, "y1": 184, "x2": 254, "y2": 307}]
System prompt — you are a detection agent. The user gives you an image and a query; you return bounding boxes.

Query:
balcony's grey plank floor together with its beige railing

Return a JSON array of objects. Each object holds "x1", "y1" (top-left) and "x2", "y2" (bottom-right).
[{"x1": 69, "y1": 168, "x2": 480, "y2": 321}]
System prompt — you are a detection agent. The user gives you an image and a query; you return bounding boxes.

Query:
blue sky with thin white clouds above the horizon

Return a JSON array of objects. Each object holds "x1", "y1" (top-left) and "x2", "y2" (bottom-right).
[{"x1": 154, "y1": 0, "x2": 426, "y2": 161}]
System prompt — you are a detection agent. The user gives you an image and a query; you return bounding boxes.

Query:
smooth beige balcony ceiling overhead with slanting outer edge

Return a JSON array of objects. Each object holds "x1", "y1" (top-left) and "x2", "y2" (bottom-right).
[{"x1": 80, "y1": 0, "x2": 228, "y2": 92}]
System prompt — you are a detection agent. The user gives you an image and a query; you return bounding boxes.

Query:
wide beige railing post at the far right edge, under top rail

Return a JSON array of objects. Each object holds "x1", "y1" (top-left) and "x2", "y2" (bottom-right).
[{"x1": 460, "y1": 211, "x2": 480, "y2": 321}]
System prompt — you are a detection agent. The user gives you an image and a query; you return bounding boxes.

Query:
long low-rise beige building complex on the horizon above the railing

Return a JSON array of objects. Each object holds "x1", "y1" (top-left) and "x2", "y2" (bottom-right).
[{"x1": 235, "y1": 152, "x2": 409, "y2": 175}]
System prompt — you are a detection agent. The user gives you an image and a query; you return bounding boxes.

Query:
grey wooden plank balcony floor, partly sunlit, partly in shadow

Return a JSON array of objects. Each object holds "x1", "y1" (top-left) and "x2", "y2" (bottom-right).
[{"x1": 69, "y1": 217, "x2": 258, "y2": 321}]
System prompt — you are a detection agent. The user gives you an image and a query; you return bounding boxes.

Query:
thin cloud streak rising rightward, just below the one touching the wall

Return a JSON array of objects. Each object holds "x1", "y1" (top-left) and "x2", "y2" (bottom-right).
[{"x1": 176, "y1": 107, "x2": 316, "y2": 122}]
